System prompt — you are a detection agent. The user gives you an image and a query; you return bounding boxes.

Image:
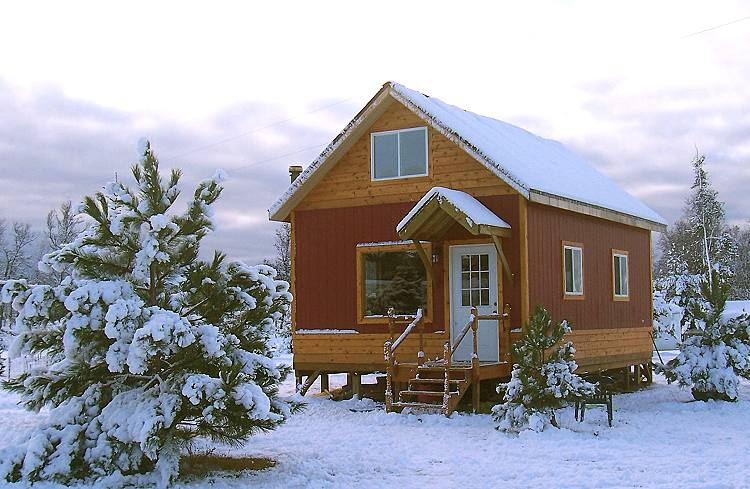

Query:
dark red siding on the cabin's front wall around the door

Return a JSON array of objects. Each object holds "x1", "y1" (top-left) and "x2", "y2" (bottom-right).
[{"x1": 294, "y1": 196, "x2": 520, "y2": 333}]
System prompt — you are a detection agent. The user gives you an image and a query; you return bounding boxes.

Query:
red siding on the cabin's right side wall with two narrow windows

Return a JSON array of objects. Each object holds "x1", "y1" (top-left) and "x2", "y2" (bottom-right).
[{"x1": 528, "y1": 203, "x2": 651, "y2": 329}]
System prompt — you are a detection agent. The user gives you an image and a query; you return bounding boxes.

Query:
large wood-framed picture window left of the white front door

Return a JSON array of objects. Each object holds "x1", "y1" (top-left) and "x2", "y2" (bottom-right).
[{"x1": 357, "y1": 243, "x2": 432, "y2": 322}]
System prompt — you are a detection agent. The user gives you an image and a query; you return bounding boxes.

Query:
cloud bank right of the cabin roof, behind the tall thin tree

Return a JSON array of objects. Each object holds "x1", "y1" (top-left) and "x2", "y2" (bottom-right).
[{"x1": 562, "y1": 75, "x2": 750, "y2": 225}]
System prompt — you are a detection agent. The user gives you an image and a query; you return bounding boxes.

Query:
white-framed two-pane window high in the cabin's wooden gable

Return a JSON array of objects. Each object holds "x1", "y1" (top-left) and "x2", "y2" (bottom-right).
[{"x1": 370, "y1": 127, "x2": 427, "y2": 180}]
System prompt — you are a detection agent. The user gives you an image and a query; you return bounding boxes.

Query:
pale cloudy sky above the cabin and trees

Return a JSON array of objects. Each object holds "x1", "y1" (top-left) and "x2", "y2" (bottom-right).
[{"x1": 0, "y1": 0, "x2": 750, "y2": 262}]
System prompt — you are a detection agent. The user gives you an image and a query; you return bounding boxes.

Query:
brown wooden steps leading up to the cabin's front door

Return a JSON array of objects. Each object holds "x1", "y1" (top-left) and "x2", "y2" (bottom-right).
[{"x1": 391, "y1": 362, "x2": 472, "y2": 414}]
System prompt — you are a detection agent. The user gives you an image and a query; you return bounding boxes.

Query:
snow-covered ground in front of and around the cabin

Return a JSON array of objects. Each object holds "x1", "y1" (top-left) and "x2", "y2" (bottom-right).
[{"x1": 0, "y1": 354, "x2": 750, "y2": 489}]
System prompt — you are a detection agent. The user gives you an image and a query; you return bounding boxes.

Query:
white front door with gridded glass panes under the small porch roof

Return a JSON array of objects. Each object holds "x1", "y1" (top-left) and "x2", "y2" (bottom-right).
[{"x1": 449, "y1": 244, "x2": 500, "y2": 362}]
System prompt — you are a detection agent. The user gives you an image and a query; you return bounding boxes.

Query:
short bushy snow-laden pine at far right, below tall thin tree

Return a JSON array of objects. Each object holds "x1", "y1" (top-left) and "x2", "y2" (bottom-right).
[{"x1": 657, "y1": 270, "x2": 750, "y2": 401}]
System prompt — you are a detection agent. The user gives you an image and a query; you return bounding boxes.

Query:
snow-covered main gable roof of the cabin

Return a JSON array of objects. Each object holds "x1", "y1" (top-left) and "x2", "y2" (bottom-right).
[{"x1": 269, "y1": 82, "x2": 666, "y2": 229}]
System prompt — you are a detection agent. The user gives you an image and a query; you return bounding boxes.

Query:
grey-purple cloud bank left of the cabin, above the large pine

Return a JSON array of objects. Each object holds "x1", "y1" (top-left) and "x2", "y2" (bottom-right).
[{"x1": 0, "y1": 82, "x2": 357, "y2": 262}]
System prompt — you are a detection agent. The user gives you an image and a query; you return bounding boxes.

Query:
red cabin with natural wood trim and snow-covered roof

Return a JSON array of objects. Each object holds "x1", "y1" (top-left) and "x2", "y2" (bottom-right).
[{"x1": 269, "y1": 82, "x2": 666, "y2": 414}]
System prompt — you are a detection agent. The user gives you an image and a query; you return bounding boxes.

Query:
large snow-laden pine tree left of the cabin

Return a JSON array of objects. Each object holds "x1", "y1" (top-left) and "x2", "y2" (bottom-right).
[{"x1": 0, "y1": 143, "x2": 296, "y2": 487}]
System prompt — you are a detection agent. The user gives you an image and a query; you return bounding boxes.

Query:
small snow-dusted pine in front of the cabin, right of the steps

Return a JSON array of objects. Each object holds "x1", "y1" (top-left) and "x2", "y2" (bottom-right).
[{"x1": 492, "y1": 305, "x2": 596, "y2": 431}]
